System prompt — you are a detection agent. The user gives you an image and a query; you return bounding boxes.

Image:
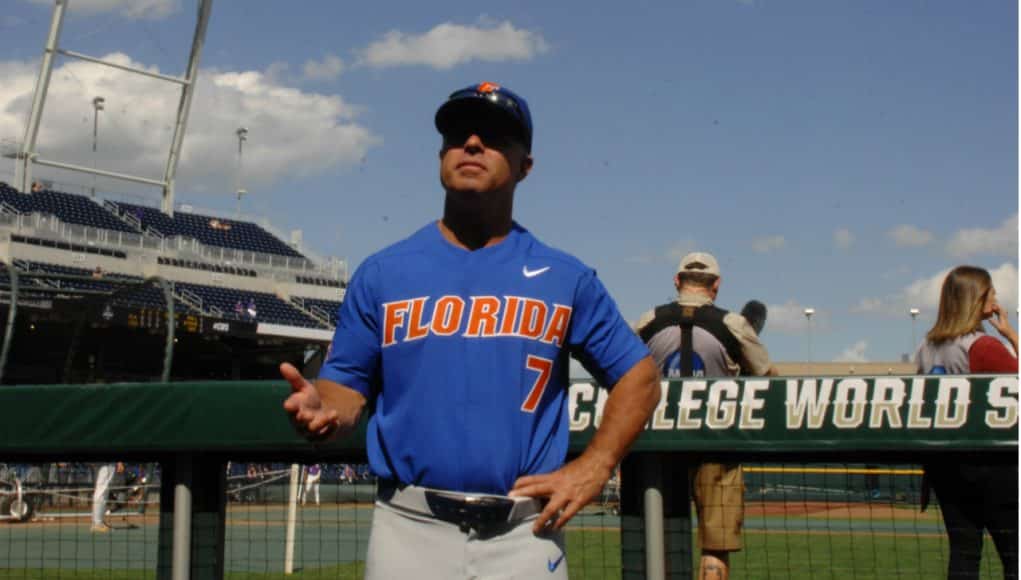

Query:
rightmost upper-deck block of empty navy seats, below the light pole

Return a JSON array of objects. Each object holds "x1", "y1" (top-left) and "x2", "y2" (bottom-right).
[{"x1": 115, "y1": 202, "x2": 304, "y2": 257}]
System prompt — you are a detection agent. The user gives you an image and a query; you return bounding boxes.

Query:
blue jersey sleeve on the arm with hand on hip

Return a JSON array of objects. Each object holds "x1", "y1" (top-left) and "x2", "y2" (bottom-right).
[{"x1": 568, "y1": 271, "x2": 648, "y2": 388}]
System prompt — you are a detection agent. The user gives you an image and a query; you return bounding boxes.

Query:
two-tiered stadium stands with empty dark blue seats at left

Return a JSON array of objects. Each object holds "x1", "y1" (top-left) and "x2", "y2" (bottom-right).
[{"x1": 0, "y1": 183, "x2": 345, "y2": 336}]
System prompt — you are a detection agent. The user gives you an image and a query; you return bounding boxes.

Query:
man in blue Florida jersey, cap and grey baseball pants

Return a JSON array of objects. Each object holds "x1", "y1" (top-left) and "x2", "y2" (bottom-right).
[{"x1": 281, "y1": 83, "x2": 660, "y2": 579}]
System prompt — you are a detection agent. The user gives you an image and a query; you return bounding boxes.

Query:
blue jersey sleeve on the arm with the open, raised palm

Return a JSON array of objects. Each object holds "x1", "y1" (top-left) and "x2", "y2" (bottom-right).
[{"x1": 319, "y1": 262, "x2": 380, "y2": 399}]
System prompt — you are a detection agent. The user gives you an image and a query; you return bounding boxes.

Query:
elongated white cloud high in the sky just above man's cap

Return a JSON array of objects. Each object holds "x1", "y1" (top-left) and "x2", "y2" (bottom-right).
[{"x1": 359, "y1": 20, "x2": 549, "y2": 69}]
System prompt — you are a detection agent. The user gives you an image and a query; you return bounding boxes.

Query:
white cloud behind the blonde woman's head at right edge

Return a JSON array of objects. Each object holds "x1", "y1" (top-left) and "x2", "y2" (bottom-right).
[{"x1": 852, "y1": 262, "x2": 1018, "y2": 318}]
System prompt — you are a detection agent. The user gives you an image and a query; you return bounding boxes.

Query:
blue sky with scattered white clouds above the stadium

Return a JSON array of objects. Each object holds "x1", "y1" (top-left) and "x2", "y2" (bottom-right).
[{"x1": 0, "y1": 0, "x2": 1018, "y2": 360}]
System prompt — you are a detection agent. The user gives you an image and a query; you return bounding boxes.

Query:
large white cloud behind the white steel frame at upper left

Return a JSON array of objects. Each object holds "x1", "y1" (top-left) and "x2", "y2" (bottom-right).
[{"x1": 0, "y1": 53, "x2": 380, "y2": 192}]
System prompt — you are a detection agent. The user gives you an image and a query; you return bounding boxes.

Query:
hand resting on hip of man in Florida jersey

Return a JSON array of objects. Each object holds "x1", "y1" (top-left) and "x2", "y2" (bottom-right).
[{"x1": 509, "y1": 454, "x2": 613, "y2": 533}]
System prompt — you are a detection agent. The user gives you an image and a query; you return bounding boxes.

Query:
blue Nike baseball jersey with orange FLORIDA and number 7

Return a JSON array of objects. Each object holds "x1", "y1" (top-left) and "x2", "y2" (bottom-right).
[{"x1": 320, "y1": 223, "x2": 648, "y2": 494}]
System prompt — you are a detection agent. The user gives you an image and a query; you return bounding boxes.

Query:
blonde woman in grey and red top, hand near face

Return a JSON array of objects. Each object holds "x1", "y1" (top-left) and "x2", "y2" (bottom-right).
[{"x1": 915, "y1": 265, "x2": 1018, "y2": 579}]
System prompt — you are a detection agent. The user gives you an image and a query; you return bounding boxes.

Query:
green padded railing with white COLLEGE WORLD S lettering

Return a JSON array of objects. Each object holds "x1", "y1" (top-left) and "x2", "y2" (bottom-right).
[{"x1": 0, "y1": 375, "x2": 1018, "y2": 461}]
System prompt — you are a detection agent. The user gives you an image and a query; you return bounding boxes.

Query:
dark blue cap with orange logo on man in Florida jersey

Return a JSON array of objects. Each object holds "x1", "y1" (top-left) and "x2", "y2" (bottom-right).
[{"x1": 436, "y1": 83, "x2": 532, "y2": 152}]
